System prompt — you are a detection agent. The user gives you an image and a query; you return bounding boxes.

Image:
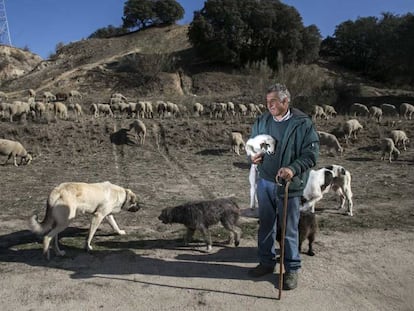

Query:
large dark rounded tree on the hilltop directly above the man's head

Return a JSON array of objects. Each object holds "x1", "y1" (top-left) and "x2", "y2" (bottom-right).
[{"x1": 188, "y1": 0, "x2": 320, "y2": 70}]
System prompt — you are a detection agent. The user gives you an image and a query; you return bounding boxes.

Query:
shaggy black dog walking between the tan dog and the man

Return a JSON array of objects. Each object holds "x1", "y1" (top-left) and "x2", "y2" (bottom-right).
[{"x1": 158, "y1": 198, "x2": 241, "y2": 251}]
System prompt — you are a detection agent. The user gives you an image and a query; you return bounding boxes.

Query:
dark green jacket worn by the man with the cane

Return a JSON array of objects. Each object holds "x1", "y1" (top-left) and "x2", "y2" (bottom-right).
[{"x1": 251, "y1": 108, "x2": 319, "y2": 197}]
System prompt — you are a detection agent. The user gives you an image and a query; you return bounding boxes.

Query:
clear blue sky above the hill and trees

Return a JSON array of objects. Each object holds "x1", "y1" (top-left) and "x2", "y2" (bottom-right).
[{"x1": 4, "y1": 0, "x2": 414, "y2": 58}]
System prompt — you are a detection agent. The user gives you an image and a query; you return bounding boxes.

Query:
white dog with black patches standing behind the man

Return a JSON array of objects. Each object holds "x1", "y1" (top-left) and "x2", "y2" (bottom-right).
[{"x1": 301, "y1": 164, "x2": 353, "y2": 216}]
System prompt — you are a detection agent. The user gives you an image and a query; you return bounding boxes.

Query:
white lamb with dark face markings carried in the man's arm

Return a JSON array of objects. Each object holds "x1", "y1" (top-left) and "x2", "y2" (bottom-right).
[{"x1": 245, "y1": 134, "x2": 276, "y2": 209}]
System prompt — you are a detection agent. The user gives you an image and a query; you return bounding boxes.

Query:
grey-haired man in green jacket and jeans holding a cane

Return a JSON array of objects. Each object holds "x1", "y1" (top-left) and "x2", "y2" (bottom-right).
[{"x1": 249, "y1": 84, "x2": 319, "y2": 290}]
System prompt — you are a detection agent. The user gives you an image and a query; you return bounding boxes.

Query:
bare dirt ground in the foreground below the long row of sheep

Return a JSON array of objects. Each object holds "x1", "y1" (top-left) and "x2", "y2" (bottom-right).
[{"x1": 0, "y1": 113, "x2": 414, "y2": 311}]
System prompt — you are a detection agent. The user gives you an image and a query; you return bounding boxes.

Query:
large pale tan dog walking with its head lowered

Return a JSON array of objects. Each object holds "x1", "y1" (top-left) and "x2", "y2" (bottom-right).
[{"x1": 30, "y1": 181, "x2": 140, "y2": 259}]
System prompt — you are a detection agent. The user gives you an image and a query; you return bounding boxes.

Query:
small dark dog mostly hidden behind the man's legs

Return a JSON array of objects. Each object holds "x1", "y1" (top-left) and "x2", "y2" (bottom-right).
[{"x1": 276, "y1": 211, "x2": 318, "y2": 256}]
